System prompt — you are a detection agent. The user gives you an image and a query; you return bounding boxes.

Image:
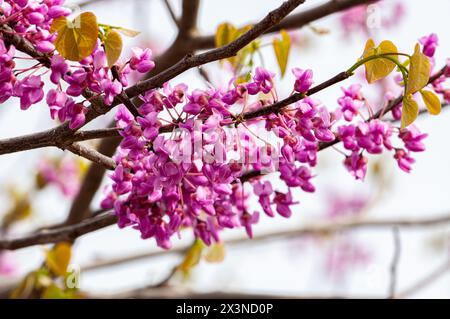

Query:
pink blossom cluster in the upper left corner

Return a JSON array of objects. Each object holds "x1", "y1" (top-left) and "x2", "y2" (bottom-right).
[{"x1": 0, "y1": 0, "x2": 155, "y2": 129}]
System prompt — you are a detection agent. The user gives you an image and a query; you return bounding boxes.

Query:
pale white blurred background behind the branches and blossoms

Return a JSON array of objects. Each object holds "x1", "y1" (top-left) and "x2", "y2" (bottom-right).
[{"x1": 0, "y1": 0, "x2": 450, "y2": 298}]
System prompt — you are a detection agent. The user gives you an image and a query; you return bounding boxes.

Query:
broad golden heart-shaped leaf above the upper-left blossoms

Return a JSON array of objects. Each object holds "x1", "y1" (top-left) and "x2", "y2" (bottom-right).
[{"x1": 50, "y1": 12, "x2": 98, "y2": 61}]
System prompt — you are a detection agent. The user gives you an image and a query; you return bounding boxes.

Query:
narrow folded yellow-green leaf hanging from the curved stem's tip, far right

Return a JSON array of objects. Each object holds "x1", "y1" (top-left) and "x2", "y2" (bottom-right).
[{"x1": 406, "y1": 44, "x2": 430, "y2": 94}]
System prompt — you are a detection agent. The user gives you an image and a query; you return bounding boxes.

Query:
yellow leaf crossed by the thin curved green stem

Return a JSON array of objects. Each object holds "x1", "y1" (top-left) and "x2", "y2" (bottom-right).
[{"x1": 363, "y1": 39, "x2": 398, "y2": 83}]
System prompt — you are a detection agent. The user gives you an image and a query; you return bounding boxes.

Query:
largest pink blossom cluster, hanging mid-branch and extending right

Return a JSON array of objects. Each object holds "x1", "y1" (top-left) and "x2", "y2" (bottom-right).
[{"x1": 98, "y1": 53, "x2": 436, "y2": 249}]
